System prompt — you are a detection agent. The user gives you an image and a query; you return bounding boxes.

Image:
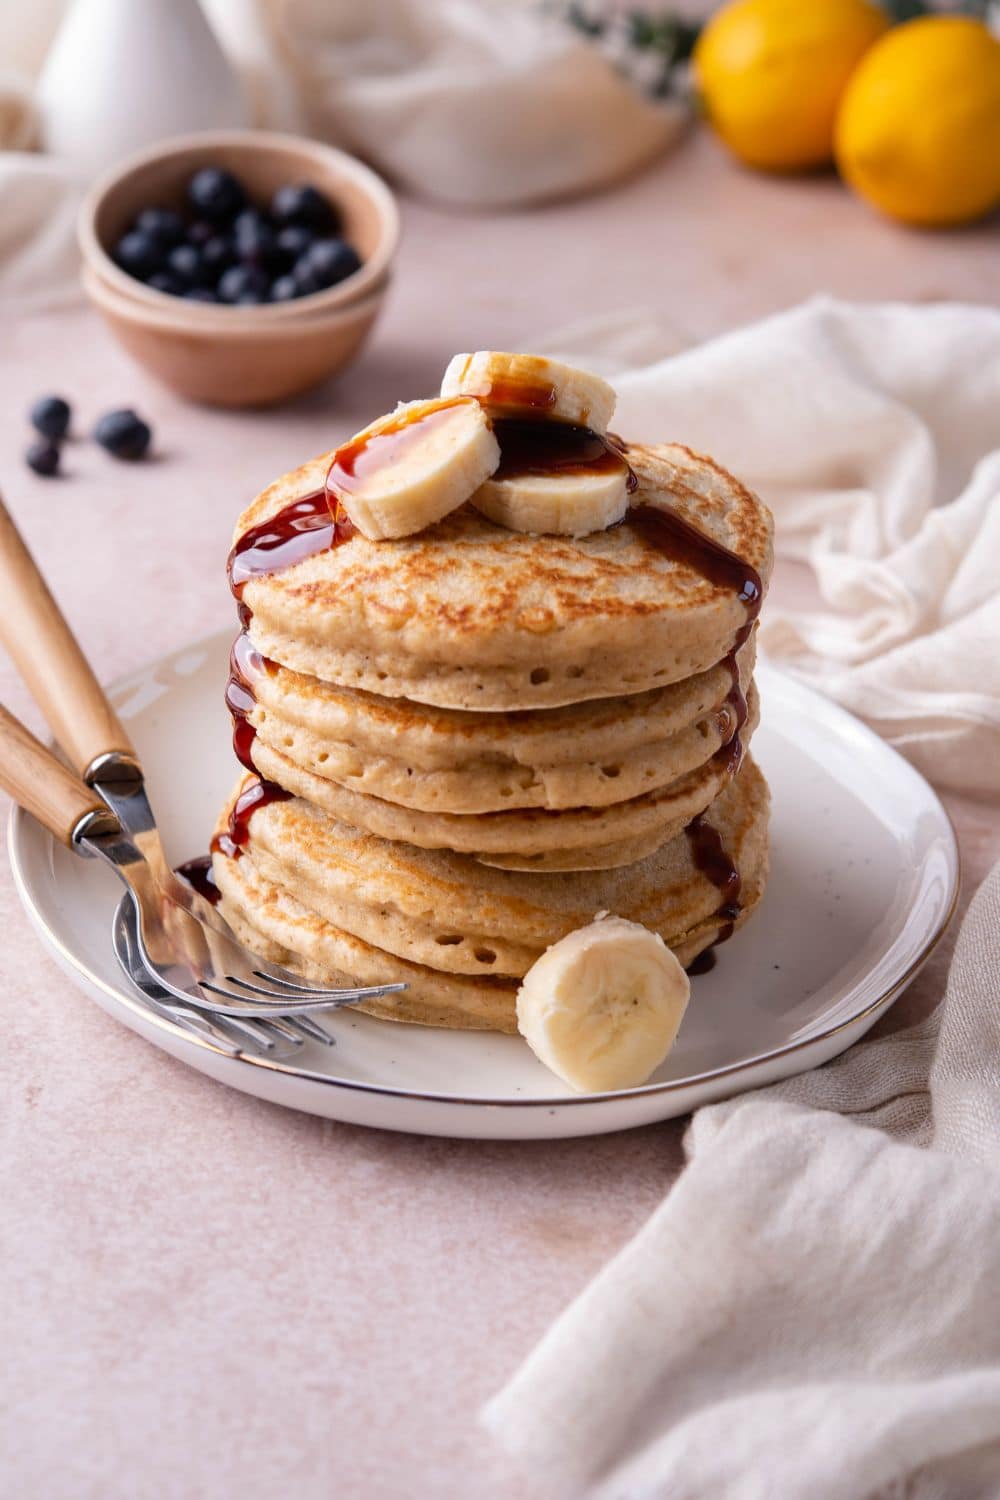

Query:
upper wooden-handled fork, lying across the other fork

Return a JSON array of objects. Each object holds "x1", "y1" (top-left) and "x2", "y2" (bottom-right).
[{"x1": 0, "y1": 500, "x2": 405, "y2": 1047}]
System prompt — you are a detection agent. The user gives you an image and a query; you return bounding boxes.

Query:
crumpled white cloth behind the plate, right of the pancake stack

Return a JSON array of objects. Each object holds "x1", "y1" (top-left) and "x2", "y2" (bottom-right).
[{"x1": 547, "y1": 299, "x2": 1000, "y2": 792}]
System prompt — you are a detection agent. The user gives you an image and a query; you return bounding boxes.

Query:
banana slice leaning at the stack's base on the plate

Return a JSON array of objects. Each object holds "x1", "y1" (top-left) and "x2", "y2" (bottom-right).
[{"x1": 517, "y1": 917, "x2": 691, "y2": 1094}]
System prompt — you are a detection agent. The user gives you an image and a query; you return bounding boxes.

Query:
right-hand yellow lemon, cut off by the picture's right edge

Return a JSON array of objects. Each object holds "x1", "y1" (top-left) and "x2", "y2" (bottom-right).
[{"x1": 837, "y1": 15, "x2": 1000, "y2": 225}]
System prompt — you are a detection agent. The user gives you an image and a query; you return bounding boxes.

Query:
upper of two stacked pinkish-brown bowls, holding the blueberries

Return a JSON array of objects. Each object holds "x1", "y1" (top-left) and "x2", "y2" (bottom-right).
[{"x1": 78, "y1": 131, "x2": 399, "y2": 327}]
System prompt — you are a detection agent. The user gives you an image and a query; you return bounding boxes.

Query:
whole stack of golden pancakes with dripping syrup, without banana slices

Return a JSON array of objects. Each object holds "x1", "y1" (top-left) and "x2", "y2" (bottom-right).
[{"x1": 213, "y1": 387, "x2": 772, "y2": 1031}]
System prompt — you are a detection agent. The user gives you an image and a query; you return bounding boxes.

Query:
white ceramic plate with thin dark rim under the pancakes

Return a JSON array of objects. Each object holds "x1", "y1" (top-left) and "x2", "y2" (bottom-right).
[{"x1": 10, "y1": 636, "x2": 958, "y2": 1140}]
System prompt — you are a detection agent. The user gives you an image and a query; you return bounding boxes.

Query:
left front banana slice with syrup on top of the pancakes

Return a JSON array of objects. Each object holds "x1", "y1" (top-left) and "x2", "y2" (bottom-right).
[{"x1": 327, "y1": 399, "x2": 499, "y2": 542}]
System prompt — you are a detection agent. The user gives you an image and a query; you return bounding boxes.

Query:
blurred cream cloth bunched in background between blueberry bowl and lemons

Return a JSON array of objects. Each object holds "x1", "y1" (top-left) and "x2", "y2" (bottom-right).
[{"x1": 258, "y1": 0, "x2": 688, "y2": 207}]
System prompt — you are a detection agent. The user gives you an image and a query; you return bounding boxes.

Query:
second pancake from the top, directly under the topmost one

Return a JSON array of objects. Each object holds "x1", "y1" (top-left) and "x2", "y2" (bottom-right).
[{"x1": 249, "y1": 644, "x2": 753, "y2": 815}]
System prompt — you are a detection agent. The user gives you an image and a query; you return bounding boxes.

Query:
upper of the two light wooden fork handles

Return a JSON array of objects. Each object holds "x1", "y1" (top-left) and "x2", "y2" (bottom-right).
[{"x1": 0, "y1": 500, "x2": 135, "y2": 777}]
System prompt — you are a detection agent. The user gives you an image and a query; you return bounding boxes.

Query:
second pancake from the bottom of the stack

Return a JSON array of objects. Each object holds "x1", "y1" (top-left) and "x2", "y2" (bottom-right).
[{"x1": 216, "y1": 759, "x2": 768, "y2": 977}]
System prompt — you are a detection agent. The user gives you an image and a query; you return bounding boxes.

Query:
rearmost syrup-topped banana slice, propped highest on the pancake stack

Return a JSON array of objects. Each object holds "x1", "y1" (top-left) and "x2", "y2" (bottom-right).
[{"x1": 441, "y1": 350, "x2": 616, "y2": 434}]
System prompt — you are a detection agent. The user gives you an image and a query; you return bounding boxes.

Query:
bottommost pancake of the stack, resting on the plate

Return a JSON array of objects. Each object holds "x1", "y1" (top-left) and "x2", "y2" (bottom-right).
[{"x1": 213, "y1": 762, "x2": 768, "y2": 1032}]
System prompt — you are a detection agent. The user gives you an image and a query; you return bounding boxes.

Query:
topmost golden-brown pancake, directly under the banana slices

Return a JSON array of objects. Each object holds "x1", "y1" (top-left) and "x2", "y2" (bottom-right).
[{"x1": 235, "y1": 444, "x2": 772, "y2": 711}]
